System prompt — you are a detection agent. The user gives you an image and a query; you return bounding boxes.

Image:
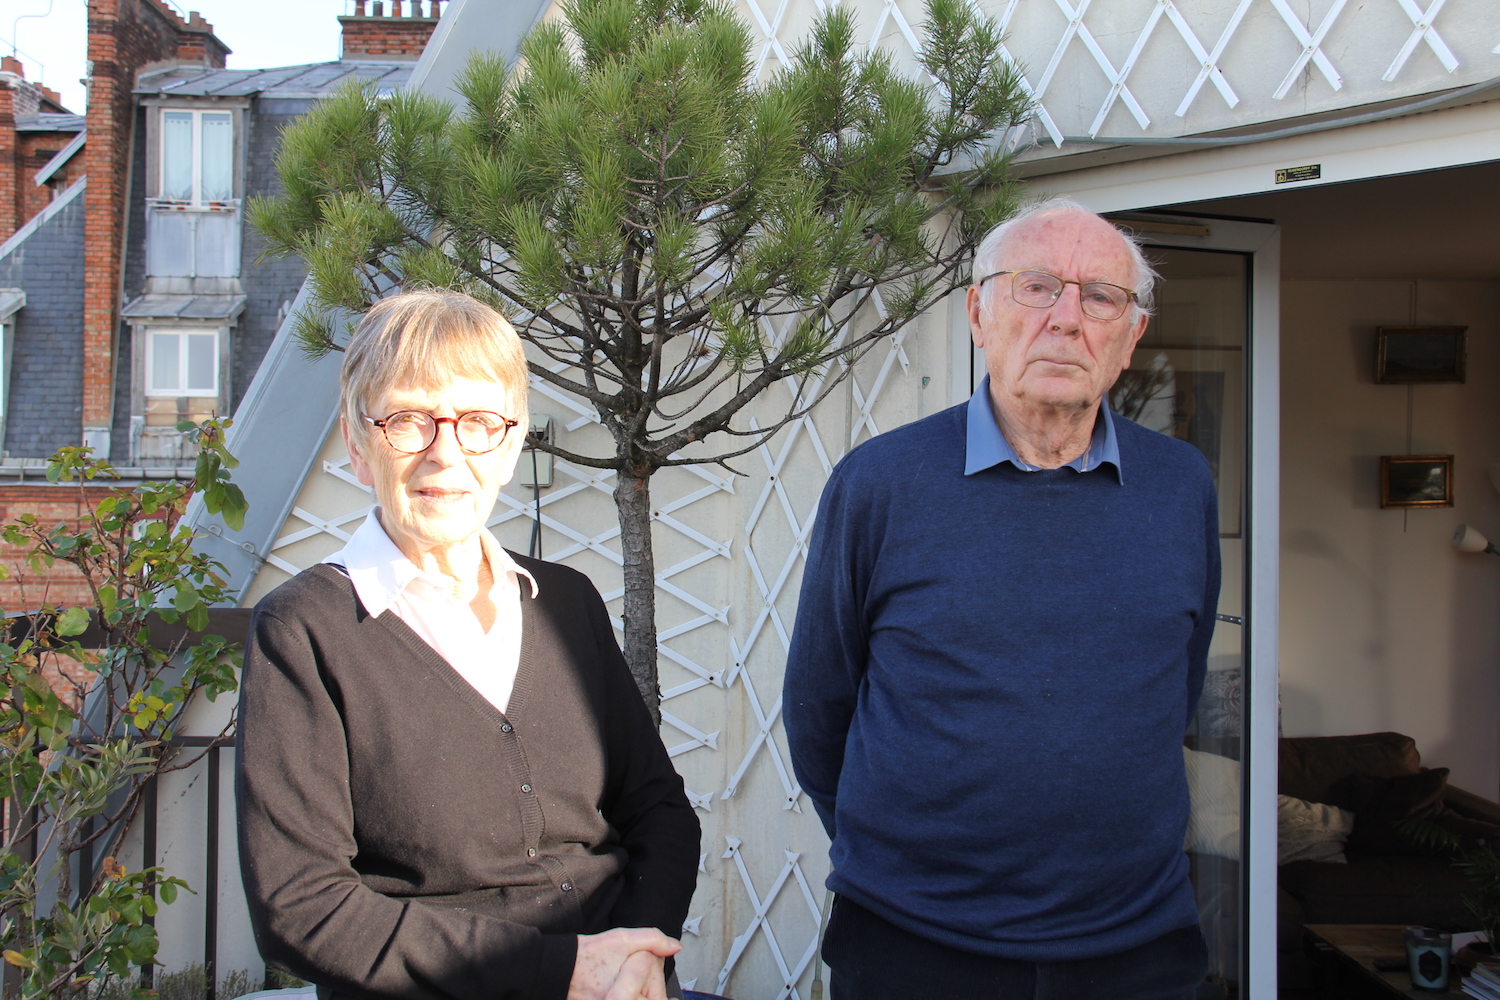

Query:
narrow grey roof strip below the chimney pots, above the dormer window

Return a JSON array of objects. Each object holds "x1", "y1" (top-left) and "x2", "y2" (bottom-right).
[{"x1": 135, "y1": 58, "x2": 416, "y2": 100}]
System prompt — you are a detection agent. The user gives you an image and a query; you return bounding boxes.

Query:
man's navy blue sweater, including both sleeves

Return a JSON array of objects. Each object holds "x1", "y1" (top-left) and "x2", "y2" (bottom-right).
[{"x1": 783, "y1": 406, "x2": 1220, "y2": 961}]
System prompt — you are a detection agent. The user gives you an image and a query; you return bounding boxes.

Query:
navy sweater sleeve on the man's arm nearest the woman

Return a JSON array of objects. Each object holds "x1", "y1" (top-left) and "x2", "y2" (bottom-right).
[{"x1": 782, "y1": 459, "x2": 873, "y2": 840}]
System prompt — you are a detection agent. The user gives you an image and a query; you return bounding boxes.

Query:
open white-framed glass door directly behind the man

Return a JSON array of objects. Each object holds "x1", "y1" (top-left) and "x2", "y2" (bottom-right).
[{"x1": 1128, "y1": 216, "x2": 1280, "y2": 1000}]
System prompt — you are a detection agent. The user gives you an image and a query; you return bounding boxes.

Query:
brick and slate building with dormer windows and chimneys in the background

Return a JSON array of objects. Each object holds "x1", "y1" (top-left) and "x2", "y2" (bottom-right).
[{"x1": 0, "y1": 0, "x2": 440, "y2": 610}]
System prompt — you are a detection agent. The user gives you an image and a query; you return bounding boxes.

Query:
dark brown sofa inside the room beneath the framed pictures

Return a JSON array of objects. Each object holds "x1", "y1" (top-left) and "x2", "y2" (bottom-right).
[{"x1": 1277, "y1": 733, "x2": 1500, "y2": 988}]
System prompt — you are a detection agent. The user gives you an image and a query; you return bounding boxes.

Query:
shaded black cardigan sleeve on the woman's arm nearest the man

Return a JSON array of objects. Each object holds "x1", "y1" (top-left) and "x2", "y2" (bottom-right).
[{"x1": 584, "y1": 580, "x2": 699, "y2": 939}]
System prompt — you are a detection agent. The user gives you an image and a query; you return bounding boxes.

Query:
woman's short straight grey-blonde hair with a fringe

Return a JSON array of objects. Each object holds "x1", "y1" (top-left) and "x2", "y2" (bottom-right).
[{"x1": 339, "y1": 288, "x2": 528, "y2": 433}]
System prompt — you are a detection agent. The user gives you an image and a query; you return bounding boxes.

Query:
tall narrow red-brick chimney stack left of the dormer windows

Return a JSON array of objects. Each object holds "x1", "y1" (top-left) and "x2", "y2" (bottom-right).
[{"x1": 83, "y1": 0, "x2": 230, "y2": 446}]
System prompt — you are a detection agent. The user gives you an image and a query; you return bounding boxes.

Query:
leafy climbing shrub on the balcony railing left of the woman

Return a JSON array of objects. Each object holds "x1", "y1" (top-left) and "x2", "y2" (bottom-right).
[{"x1": 0, "y1": 421, "x2": 245, "y2": 1000}]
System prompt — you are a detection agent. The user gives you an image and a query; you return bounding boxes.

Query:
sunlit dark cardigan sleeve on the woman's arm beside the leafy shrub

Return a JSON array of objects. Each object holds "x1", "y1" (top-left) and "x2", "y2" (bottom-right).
[{"x1": 236, "y1": 602, "x2": 578, "y2": 1000}]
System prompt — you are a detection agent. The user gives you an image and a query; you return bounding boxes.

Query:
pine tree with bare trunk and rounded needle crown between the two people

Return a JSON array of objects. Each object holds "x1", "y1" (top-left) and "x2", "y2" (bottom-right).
[{"x1": 249, "y1": 0, "x2": 1031, "y2": 712}]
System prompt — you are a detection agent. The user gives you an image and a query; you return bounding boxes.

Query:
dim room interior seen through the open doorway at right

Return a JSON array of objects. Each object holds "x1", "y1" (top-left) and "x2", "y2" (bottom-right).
[{"x1": 1164, "y1": 163, "x2": 1500, "y2": 997}]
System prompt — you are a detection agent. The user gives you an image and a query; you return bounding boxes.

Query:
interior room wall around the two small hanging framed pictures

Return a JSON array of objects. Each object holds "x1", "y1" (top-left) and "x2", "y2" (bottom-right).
[{"x1": 1281, "y1": 280, "x2": 1500, "y2": 798}]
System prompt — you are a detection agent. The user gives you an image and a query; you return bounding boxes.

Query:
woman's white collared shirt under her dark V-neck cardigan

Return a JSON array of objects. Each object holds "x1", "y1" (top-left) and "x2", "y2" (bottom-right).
[{"x1": 324, "y1": 508, "x2": 537, "y2": 712}]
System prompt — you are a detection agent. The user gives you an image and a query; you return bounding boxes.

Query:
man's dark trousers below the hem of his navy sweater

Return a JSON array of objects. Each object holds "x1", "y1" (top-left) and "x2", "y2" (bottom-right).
[{"x1": 824, "y1": 897, "x2": 1208, "y2": 1000}]
